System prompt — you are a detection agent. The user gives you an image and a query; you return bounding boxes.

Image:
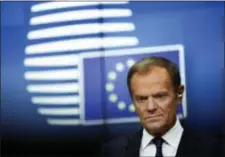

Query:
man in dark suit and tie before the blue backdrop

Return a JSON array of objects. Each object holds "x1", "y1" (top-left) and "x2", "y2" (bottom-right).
[{"x1": 101, "y1": 56, "x2": 219, "y2": 157}]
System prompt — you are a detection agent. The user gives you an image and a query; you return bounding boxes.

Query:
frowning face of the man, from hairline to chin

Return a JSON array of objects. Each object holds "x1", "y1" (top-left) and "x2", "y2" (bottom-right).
[{"x1": 131, "y1": 67, "x2": 183, "y2": 135}]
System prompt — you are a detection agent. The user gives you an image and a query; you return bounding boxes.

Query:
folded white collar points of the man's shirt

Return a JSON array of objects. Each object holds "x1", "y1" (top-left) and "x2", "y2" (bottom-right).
[{"x1": 141, "y1": 118, "x2": 183, "y2": 149}]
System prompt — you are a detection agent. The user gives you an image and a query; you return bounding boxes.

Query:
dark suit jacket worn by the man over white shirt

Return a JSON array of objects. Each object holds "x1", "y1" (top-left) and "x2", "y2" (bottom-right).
[{"x1": 100, "y1": 122, "x2": 224, "y2": 157}]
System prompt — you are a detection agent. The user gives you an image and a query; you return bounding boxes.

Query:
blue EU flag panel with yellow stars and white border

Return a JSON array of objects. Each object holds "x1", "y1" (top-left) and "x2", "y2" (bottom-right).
[{"x1": 81, "y1": 45, "x2": 186, "y2": 124}]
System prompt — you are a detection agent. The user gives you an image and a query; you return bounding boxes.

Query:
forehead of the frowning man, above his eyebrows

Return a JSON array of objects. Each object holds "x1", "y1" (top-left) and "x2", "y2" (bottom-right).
[{"x1": 131, "y1": 67, "x2": 172, "y2": 91}]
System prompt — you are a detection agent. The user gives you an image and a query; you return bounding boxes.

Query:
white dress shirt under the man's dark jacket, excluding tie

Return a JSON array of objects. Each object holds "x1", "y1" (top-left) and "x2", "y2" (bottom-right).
[{"x1": 139, "y1": 118, "x2": 183, "y2": 157}]
